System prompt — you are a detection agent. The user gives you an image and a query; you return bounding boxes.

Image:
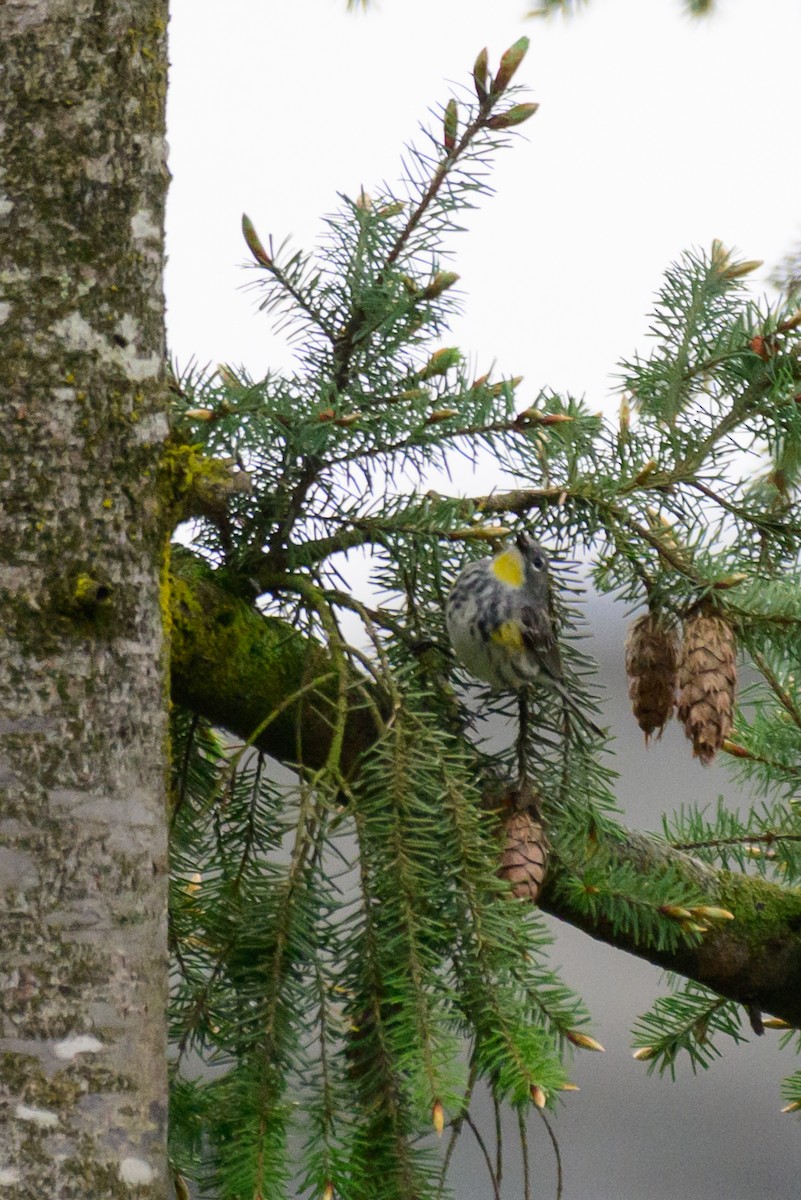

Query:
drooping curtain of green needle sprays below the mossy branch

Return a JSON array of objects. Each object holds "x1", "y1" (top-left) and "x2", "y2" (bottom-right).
[{"x1": 170, "y1": 689, "x2": 588, "y2": 1198}]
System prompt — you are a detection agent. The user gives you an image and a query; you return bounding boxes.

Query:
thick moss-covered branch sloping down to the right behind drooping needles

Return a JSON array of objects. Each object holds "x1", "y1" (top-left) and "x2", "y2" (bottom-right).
[{"x1": 171, "y1": 575, "x2": 801, "y2": 1027}]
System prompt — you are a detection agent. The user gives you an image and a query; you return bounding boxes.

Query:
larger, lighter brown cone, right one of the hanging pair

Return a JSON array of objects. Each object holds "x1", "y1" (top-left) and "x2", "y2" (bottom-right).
[{"x1": 679, "y1": 613, "x2": 737, "y2": 764}]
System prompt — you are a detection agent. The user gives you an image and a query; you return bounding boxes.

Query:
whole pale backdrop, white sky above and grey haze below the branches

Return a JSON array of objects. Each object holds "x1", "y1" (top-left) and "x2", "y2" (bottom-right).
[{"x1": 167, "y1": 0, "x2": 801, "y2": 1200}]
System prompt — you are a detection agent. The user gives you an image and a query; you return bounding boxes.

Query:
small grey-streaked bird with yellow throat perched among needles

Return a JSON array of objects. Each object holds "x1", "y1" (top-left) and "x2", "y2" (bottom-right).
[{"x1": 445, "y1": 533, "x2": 603, "y2": 737}]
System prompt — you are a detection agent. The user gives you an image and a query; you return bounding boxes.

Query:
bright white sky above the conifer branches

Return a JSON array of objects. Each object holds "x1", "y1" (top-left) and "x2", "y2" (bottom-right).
[{"x1": 167, "y1": 0, "x2": 801, "y2": 403}]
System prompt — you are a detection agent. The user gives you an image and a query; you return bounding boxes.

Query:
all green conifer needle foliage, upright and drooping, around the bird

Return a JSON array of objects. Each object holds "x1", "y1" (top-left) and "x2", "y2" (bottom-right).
[{"x1": 170, "y1": 37, "x2": 801, "y2": 1200}]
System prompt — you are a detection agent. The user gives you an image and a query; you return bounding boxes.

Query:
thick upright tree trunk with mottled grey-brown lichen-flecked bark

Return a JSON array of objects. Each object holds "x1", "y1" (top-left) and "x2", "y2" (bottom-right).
[{"x1": 0, "y1": 0, "x2": 168, "y2": 1200}]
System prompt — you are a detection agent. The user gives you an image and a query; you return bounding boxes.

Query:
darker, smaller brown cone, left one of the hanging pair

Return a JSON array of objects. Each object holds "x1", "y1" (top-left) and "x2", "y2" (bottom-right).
[{"x1": 626, "y1": 612, "x2": 679, "y2": 745}]
